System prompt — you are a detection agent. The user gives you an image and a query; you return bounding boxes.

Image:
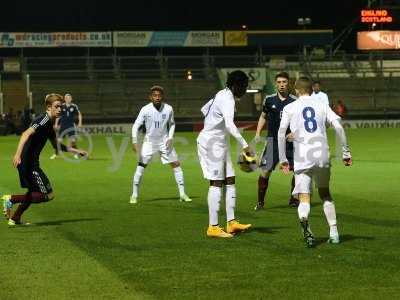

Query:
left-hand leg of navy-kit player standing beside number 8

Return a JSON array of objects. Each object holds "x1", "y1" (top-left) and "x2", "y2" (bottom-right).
[{"x1": 254, "y1": 137, "x2": 279, "y2": 210}]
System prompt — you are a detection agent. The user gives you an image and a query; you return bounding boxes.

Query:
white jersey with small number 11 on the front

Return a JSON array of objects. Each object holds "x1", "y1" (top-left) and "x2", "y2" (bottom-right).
[{"x1": 133, "y1": 103, "x2": 175, "y2": 142}]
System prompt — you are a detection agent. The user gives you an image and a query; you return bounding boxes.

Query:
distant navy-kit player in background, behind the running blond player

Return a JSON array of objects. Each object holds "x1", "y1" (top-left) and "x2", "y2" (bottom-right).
[{"x1": 50, "y1": 94, "x2": 82, "y2": 159}]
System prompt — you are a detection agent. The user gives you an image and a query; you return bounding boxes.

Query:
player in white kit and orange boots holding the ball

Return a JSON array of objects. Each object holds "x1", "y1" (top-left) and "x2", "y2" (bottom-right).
[{"x1": 197, "y1": 71, "x2": 251, "y2": 238}]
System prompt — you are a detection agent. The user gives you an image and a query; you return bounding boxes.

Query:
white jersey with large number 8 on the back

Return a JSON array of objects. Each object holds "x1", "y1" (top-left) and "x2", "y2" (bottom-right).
[{"x1": 281, "y1": 96, "x2": 340, "y2": 171}]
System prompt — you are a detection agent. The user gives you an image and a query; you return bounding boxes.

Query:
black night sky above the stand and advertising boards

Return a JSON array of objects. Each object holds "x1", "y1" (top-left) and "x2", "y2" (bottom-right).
[{"x1": 0, "y1": 0, "x2": 400, "y2": 49}]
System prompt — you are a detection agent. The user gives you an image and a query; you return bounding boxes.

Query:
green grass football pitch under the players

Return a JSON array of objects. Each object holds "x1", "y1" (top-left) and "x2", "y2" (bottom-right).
[{"x1": 0, "y1": 129, "x2": 400, "y2": 300}]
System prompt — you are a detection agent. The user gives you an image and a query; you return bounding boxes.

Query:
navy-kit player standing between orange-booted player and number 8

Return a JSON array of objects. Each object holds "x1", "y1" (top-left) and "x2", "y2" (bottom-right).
[{"x1": 254, "y1": 72, "x2": 298, "y2": 210}]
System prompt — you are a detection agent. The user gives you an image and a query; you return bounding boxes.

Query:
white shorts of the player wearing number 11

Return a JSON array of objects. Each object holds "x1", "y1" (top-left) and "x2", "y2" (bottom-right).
[{"x1": 140, "y1": 142, "x2": 178, "y2": 165}]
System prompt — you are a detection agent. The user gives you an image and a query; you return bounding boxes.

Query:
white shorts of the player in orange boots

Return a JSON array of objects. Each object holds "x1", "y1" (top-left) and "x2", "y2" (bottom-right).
[{"x1": 197, "y1": 137, "x2": 235, "y2": 180}]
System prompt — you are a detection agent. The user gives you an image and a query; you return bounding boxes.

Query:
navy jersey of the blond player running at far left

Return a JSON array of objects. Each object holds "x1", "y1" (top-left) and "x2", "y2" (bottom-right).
[{"x1": 21, "y1": 113, "x2": 56, "y2": 164}]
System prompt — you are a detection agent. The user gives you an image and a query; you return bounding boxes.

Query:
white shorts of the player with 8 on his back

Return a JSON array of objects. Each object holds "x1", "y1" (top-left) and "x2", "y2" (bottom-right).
[{"x1": 292, "y1": 167, "x2": 331, "y2": 196}]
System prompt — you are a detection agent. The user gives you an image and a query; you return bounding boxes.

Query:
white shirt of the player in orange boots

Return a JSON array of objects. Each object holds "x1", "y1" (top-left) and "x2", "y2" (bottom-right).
[{"x1": 200, "y1": 88, "x2": 248, "y2": 148}]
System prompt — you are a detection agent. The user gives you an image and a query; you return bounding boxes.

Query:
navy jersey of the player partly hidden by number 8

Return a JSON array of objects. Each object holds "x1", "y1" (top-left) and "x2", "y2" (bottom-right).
[{"x1": 262, "y1": 93, "x2": 297, "y2": 139}]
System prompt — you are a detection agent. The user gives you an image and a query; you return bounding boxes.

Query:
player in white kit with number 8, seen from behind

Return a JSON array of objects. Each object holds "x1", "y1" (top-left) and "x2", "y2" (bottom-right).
[{"x1": 278, "y1": 77, "x2": 352, "y2": 247}]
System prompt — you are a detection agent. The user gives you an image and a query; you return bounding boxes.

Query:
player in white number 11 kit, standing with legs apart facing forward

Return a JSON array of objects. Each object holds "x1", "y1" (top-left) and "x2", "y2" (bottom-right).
[{"x1": 130, "y1": 86, "x2": 192, "y2": 204}]
